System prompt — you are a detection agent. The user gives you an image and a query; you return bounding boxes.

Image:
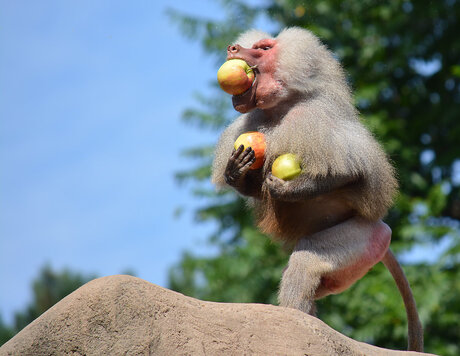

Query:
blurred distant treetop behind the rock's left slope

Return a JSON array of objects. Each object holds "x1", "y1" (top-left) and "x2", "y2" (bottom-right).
[{"x1": 0, "y1": 266, "x2": 95, "y2": 346}]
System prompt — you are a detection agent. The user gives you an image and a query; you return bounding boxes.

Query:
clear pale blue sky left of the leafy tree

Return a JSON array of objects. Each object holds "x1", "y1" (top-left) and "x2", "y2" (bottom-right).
[{"x1": 0, "y1": 0, "x2": 272, "y2": 323}]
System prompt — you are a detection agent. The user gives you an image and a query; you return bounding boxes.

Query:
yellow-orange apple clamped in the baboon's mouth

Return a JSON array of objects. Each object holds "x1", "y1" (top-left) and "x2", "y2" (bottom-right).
[{"x1": 217, "y1": 59, "x2": 255, "y2": 95}]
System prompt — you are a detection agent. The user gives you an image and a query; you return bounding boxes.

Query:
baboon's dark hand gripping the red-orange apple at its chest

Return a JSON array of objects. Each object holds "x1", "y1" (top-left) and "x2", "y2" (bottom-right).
[{"x1": 224, "y1": 145, "x2": 256, "y2": 187}]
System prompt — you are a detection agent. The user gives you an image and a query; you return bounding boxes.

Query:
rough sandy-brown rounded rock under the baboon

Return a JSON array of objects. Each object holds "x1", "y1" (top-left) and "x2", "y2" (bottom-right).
[{"x1": 0, "y1": 276, "x2": 434, "y2": 356}]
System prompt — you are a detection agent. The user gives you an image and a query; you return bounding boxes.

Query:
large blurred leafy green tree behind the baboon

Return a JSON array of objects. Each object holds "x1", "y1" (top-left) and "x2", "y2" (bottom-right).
[{"x1": 170, "y1": 0, "x2": 460, "y2": 355}]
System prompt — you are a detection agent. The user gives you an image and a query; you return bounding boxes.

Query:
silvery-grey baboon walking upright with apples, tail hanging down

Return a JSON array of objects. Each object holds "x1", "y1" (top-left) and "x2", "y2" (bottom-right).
[{"x1": 212, "y1": 28, "x2": 423, "y2": 351}]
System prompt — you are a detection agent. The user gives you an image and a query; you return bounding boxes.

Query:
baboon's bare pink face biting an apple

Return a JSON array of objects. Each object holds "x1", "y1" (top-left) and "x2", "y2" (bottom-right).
[{"x1": 227, "y1": 38, "x2": 283, "y2": 113}]
